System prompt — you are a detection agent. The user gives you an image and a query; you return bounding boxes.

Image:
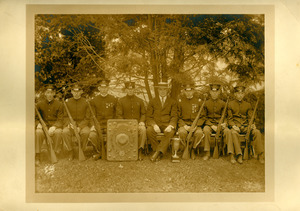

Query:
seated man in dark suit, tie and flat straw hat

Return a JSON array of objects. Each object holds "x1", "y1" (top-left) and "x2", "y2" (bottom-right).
[{"x1": 146, "y1": 82, "x2": 177, "y2": 162}]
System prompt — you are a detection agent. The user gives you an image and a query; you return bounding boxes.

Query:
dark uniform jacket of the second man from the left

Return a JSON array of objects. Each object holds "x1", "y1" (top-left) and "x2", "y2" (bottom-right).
[{"x1": 64, "y1": 97, "x2": 90, "y2": 129}]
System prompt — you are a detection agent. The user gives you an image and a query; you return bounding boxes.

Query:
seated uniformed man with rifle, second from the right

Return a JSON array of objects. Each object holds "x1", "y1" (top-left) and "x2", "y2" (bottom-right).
[{"x1": 203, "y1": 83, "x2": 232, "y2": 160}]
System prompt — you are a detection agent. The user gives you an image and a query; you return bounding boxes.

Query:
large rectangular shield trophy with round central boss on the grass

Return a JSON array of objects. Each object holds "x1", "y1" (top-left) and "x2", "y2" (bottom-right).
[{"x1": 107, "y1": 119, "x2": 138, "y2": 161}]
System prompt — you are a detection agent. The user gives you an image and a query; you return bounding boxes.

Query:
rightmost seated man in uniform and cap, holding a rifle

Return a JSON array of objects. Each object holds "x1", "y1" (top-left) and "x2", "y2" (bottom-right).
[{"x1": 228, "y1": 83, "x2": 264, "y2": 163}]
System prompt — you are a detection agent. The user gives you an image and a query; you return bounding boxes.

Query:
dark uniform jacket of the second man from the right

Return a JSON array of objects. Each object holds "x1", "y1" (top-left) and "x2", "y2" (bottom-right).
[{"x1": 204, "y1": 99, "x2": 227, "y2": 126}]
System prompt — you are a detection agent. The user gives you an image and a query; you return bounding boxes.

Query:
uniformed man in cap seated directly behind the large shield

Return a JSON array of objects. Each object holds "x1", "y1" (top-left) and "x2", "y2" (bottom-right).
[{"x1": 116, "y1": 82, "x2": 146, "y2": 160}]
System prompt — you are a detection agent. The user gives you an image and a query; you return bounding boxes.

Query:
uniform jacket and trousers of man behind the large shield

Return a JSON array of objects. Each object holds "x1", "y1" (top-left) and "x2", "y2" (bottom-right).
[{"x1": 116, "y1": 95, "x2": 146, "y2": 149}]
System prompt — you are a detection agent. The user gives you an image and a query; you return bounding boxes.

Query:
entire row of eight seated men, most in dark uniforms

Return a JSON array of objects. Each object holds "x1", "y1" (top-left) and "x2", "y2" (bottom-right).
[{"x1": 35, "y1": 80, "x2": 264, "y2": 166}]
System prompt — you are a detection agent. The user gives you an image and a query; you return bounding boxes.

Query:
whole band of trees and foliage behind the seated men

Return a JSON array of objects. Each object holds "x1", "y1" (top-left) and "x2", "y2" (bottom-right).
[{"x1": 35, "y1": 14, "x2": 264, "y2": 99}]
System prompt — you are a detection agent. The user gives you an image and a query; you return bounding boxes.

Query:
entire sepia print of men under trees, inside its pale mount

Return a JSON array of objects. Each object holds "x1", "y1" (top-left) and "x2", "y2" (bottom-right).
[{"x1": 27, "y1": 6, "x2": 272, "y2": 203}]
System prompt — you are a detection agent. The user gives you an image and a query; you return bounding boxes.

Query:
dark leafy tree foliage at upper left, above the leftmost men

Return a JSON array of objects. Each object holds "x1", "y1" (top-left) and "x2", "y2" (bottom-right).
[{"x1": 35, "y1": 15, "x2": 105, "y2": 94}]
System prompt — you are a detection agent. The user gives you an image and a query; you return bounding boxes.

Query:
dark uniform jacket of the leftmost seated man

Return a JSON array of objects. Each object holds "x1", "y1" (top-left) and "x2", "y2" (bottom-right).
[{"x1": 36, "y1": 99, "x2": 64, "y2": 128}]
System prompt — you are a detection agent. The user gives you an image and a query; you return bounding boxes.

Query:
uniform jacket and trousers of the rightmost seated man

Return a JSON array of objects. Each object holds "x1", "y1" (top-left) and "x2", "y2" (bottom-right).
[{"x1": 228, "y1": 86, "x2": 264, "y2": 163}]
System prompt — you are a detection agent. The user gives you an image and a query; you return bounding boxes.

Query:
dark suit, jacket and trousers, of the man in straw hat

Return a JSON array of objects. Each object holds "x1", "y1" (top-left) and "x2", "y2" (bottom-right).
[{"x1": 146, "y1": 85, "x2": 177, "y2": 157}]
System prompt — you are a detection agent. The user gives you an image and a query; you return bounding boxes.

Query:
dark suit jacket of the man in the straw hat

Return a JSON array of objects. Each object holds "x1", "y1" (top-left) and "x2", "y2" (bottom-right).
[{"x1": 146, "y1": 96, "x2": 177, "y2": 128}]
